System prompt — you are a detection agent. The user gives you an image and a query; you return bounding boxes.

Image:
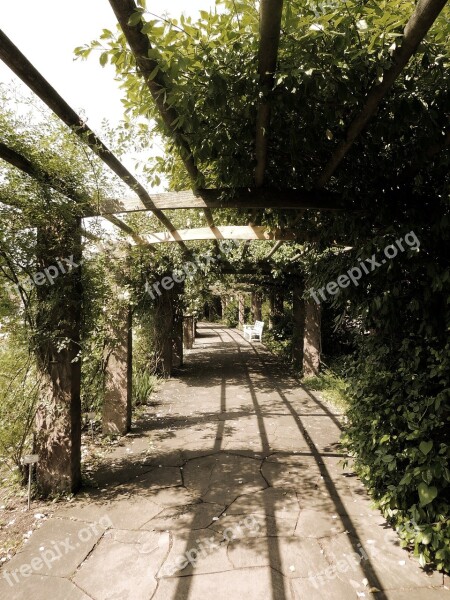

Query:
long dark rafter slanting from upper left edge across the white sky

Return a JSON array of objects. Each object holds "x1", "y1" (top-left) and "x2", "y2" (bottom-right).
[{"x1": 0, "y1": 30, "x2": 187, "y2": 251}]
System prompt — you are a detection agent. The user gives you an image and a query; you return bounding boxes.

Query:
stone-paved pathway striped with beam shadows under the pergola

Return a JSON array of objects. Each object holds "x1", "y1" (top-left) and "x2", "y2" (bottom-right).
[{"x1": 0, "y1": 324, "x2": 450, "y2": 600}]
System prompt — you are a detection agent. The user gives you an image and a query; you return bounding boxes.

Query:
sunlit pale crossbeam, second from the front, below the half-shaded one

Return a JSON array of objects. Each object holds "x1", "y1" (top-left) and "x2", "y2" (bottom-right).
[{"x1": 143, "y1": 225, "x2": 297, "y2": 244}]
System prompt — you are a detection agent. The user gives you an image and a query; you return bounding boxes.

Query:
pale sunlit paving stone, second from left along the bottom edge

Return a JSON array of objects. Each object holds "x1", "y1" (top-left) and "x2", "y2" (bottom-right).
[{"x1": 73, "y1": 531, "x2": 170, "y2": 600}]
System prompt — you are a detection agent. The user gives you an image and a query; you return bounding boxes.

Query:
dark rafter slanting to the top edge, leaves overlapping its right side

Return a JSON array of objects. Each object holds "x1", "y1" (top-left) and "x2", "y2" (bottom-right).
[{"x1": 109, "y1": 0, "x2": 221, "y2": 244}]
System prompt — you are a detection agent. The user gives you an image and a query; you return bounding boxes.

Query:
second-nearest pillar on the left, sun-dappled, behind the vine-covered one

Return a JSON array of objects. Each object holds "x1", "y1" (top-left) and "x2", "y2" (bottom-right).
[{"x1": 102, "y1": 305, "x2": 133, "y2": 435}]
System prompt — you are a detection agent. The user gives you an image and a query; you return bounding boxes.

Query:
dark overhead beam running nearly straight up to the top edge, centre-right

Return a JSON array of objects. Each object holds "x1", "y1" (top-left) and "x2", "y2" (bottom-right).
[{"x1": 255, "y1": 0, "x2": 283, "y2": 187}]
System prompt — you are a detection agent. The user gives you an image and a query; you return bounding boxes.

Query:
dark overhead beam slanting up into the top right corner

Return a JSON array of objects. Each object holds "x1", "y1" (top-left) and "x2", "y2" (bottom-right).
[{"x1": 316, "y1": 0, "x2": 447, "y2": 188}]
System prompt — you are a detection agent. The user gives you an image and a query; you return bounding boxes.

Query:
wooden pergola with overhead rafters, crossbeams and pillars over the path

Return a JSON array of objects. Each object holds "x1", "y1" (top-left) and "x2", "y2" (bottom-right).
[{"x1": 0, "y1": 0, "x2": 450, "y2": 490}]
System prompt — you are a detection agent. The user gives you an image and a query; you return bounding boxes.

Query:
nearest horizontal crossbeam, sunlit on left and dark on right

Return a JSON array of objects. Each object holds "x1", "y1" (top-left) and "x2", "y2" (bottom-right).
[{"x1": 97, "y1": 188, "x2": 342, "y2": 216}]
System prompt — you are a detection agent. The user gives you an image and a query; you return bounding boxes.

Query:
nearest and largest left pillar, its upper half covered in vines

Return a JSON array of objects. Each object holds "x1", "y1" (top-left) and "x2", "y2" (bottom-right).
[{"x1": 32, "y1": 211, "x2": 83, "y2": 496}]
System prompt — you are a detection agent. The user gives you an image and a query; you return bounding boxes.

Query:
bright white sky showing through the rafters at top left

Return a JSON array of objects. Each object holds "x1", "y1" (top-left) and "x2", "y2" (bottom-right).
[{"x1": 0, "y1": 0, "x2": 214, "y2": 132}]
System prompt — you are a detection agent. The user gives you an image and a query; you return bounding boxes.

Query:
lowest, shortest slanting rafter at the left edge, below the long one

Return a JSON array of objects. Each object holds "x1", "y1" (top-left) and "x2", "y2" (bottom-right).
[{"x1": 0, "y1": 142, "x2": 151, "y2": 244}]
